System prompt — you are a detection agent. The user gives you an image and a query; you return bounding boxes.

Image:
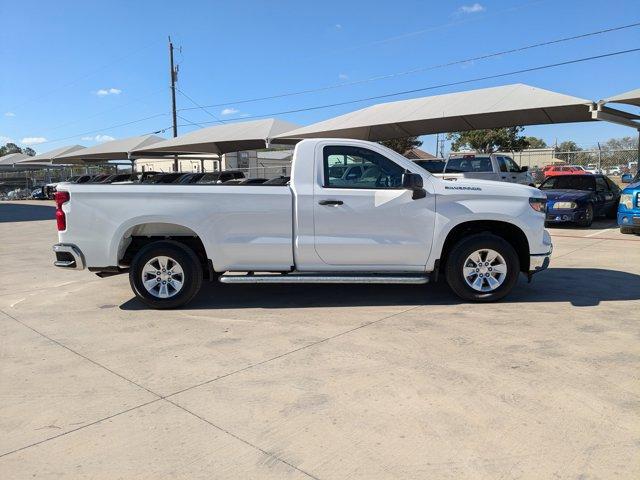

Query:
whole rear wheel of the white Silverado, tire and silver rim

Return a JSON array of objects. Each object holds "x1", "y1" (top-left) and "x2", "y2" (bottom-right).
[{"x1": 129, "y1": 240, "x2": 202, "y2": 309}]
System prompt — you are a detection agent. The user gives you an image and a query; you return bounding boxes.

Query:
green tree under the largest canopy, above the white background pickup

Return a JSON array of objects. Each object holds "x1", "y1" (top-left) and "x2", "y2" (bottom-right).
[{"x1": 447, "y1": 127, "x2": 528, "y2": 153}]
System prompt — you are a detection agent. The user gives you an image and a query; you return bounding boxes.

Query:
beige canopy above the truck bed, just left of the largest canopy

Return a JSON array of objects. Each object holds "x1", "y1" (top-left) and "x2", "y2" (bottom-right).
[{"x1": 133, "y1": 118, "x2": 300, "y2": 157}]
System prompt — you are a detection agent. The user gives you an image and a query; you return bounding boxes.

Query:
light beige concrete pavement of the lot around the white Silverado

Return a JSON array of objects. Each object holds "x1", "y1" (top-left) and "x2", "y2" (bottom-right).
[{"x1": 0, "y1": 202, "x2": 640, "y2": 479}]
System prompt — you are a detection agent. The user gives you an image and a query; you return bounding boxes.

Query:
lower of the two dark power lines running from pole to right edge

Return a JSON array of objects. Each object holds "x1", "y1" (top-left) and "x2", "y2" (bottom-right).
[{"x1": 170, "y1": 48, "x2": 640, "y2": 124}]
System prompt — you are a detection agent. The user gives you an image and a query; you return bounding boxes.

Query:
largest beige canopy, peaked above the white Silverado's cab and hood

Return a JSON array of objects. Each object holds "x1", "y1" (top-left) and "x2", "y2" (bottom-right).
[{"x1": 277, "y1": 83, "x2": 616, "y2": 141}]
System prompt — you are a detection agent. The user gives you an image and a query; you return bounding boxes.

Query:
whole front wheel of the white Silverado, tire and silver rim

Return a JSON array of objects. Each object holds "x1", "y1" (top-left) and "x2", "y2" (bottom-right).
[{"x1": 445, "y1": 233, "x2": 520, "y2": 302}]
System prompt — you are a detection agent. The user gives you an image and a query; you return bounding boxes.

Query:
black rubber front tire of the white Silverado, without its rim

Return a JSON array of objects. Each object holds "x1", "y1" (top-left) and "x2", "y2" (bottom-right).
[{"x1": 445, "y1": 233, "x2": 520, "y2": 302}]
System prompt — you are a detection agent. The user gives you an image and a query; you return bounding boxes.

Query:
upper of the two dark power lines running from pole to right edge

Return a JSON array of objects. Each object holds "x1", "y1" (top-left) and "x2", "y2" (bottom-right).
[{"x1": 179, "y1": 22, "x2": 640, "y2": 111}]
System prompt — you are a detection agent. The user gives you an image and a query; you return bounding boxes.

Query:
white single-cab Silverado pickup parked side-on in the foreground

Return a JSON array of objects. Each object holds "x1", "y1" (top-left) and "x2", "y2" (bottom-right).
[{"x1": 53, "y1": 139, "x2": 552, "y2": 308}]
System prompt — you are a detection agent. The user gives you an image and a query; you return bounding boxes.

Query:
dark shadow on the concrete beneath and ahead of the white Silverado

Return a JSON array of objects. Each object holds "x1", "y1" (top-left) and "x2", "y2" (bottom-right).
[{"x1": 120, "y1": 268, "x2": 640, "y2": 310}]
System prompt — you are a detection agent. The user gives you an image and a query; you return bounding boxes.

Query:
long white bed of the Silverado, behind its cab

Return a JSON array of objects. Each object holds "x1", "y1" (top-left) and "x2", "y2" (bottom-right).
[{"x1": 59, "y1": 184, "x2": 293, "y2": 271}]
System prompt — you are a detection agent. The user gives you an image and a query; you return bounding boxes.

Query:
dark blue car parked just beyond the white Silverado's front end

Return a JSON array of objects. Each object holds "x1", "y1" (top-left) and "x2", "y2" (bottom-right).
[{"x1": 539, "y1": 173, "x2": 620, "y2": 227}]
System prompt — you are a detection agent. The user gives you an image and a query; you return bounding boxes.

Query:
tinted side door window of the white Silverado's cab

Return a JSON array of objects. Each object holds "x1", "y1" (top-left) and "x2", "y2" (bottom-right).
[{"x1": 323, "y1": 145, "x2": 404, "y2": 189}]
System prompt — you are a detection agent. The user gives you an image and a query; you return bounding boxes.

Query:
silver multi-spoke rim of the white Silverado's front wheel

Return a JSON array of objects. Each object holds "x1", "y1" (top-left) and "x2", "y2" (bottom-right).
[{"x1": 462, "y1": 248, "x2": 507, "y2": 292}]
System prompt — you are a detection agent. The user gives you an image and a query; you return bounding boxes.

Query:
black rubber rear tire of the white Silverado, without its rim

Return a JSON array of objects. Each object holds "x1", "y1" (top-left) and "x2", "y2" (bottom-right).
[{"x1": 129, "y1": 240, "x2": 203, "y2": 309}]
